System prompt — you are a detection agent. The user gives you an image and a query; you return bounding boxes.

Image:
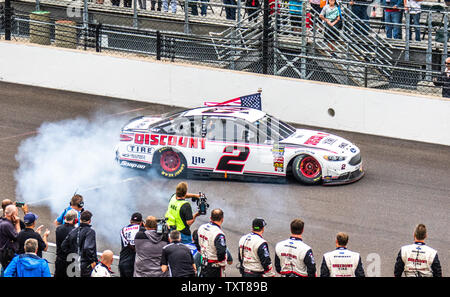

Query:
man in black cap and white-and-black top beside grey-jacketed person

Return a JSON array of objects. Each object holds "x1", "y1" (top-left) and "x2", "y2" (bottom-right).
[{"x1": 119, "y1": 212, "x2": 143, "y2": 277}]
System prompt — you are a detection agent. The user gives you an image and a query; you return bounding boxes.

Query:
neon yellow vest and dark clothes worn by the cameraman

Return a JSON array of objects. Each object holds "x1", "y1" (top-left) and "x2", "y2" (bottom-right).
[{"x1": 165, "y1": 194, "x2": 193, "y2": 243}]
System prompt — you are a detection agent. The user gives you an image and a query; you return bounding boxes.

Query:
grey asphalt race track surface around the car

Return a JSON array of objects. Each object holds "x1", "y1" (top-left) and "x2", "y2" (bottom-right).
[{"x1": 0, "y1": 82, "x2": 450, "y2": 277}]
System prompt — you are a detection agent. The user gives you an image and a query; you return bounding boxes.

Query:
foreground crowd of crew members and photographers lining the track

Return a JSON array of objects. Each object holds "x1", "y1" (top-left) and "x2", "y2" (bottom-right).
[{"x1": 0, "y1": 182, "x2": 442, "y2": 278}]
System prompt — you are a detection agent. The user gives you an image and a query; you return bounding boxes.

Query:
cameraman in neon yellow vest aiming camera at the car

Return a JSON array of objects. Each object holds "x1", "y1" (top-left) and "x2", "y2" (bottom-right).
[{"x1": 165, "y1": 182, "x2": 200, "y2": 243}]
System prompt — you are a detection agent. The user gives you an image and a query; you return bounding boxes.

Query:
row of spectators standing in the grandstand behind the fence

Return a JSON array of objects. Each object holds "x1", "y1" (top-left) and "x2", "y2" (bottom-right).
[{"x1": 92, "y1": 0, "x2": 423, "y2": 41}]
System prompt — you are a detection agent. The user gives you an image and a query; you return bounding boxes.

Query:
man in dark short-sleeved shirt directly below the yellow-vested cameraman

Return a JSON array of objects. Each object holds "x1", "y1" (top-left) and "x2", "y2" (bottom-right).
[{"x1": 161, "y1": 230, "x2": 197, "y2": 277}]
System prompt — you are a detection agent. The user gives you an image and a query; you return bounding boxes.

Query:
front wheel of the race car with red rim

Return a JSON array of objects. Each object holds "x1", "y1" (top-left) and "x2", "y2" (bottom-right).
[{"x1": 292, "y1": 155, "x2": 322, "y2": 185}]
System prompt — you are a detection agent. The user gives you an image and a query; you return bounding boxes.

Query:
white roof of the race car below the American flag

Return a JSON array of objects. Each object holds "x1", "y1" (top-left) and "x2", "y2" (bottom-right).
[{"x1": 182, "y1": 106, "x2": 266, "y2": 123}]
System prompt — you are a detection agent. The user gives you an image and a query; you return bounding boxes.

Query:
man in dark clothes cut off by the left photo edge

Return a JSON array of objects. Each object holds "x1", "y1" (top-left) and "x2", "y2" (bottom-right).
[{"x1": 0, "y1": 204, "x2": 20, "y2": 274}]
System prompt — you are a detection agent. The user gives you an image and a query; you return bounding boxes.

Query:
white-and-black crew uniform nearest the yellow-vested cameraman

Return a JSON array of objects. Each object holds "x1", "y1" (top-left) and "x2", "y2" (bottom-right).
[{"x1": 198, "y1": 222, "x2": 227, "y2": 277}]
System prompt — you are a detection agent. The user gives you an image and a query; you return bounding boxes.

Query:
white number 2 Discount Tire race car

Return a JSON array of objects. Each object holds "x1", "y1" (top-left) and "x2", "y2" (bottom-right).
[{"x1": 116, "y1": 106, "x2": 364, "y2": 185}]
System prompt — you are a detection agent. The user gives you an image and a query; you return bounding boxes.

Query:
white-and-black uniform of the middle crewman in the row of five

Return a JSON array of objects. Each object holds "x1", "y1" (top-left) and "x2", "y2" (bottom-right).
[{"x1": 275, "y1": 237, "x2": 316, "y2": 277}]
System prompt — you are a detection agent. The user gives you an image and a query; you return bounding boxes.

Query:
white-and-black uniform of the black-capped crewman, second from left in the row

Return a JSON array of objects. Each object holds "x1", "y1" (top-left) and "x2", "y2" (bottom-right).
[{"x1": 239, "y1": 232, "x2": 275, "y2": 277}]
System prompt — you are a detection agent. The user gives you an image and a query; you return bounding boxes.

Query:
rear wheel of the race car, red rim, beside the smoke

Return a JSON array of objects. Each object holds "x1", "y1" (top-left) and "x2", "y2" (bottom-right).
[{"x1": 153, "y1": 147, "x2": 187, "y2": 178}]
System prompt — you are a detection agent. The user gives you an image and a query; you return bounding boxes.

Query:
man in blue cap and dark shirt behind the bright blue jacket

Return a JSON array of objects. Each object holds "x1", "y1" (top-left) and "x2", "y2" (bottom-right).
[{"x1": 17, "y1": 212, "x2": 50, "y2": 258}]
